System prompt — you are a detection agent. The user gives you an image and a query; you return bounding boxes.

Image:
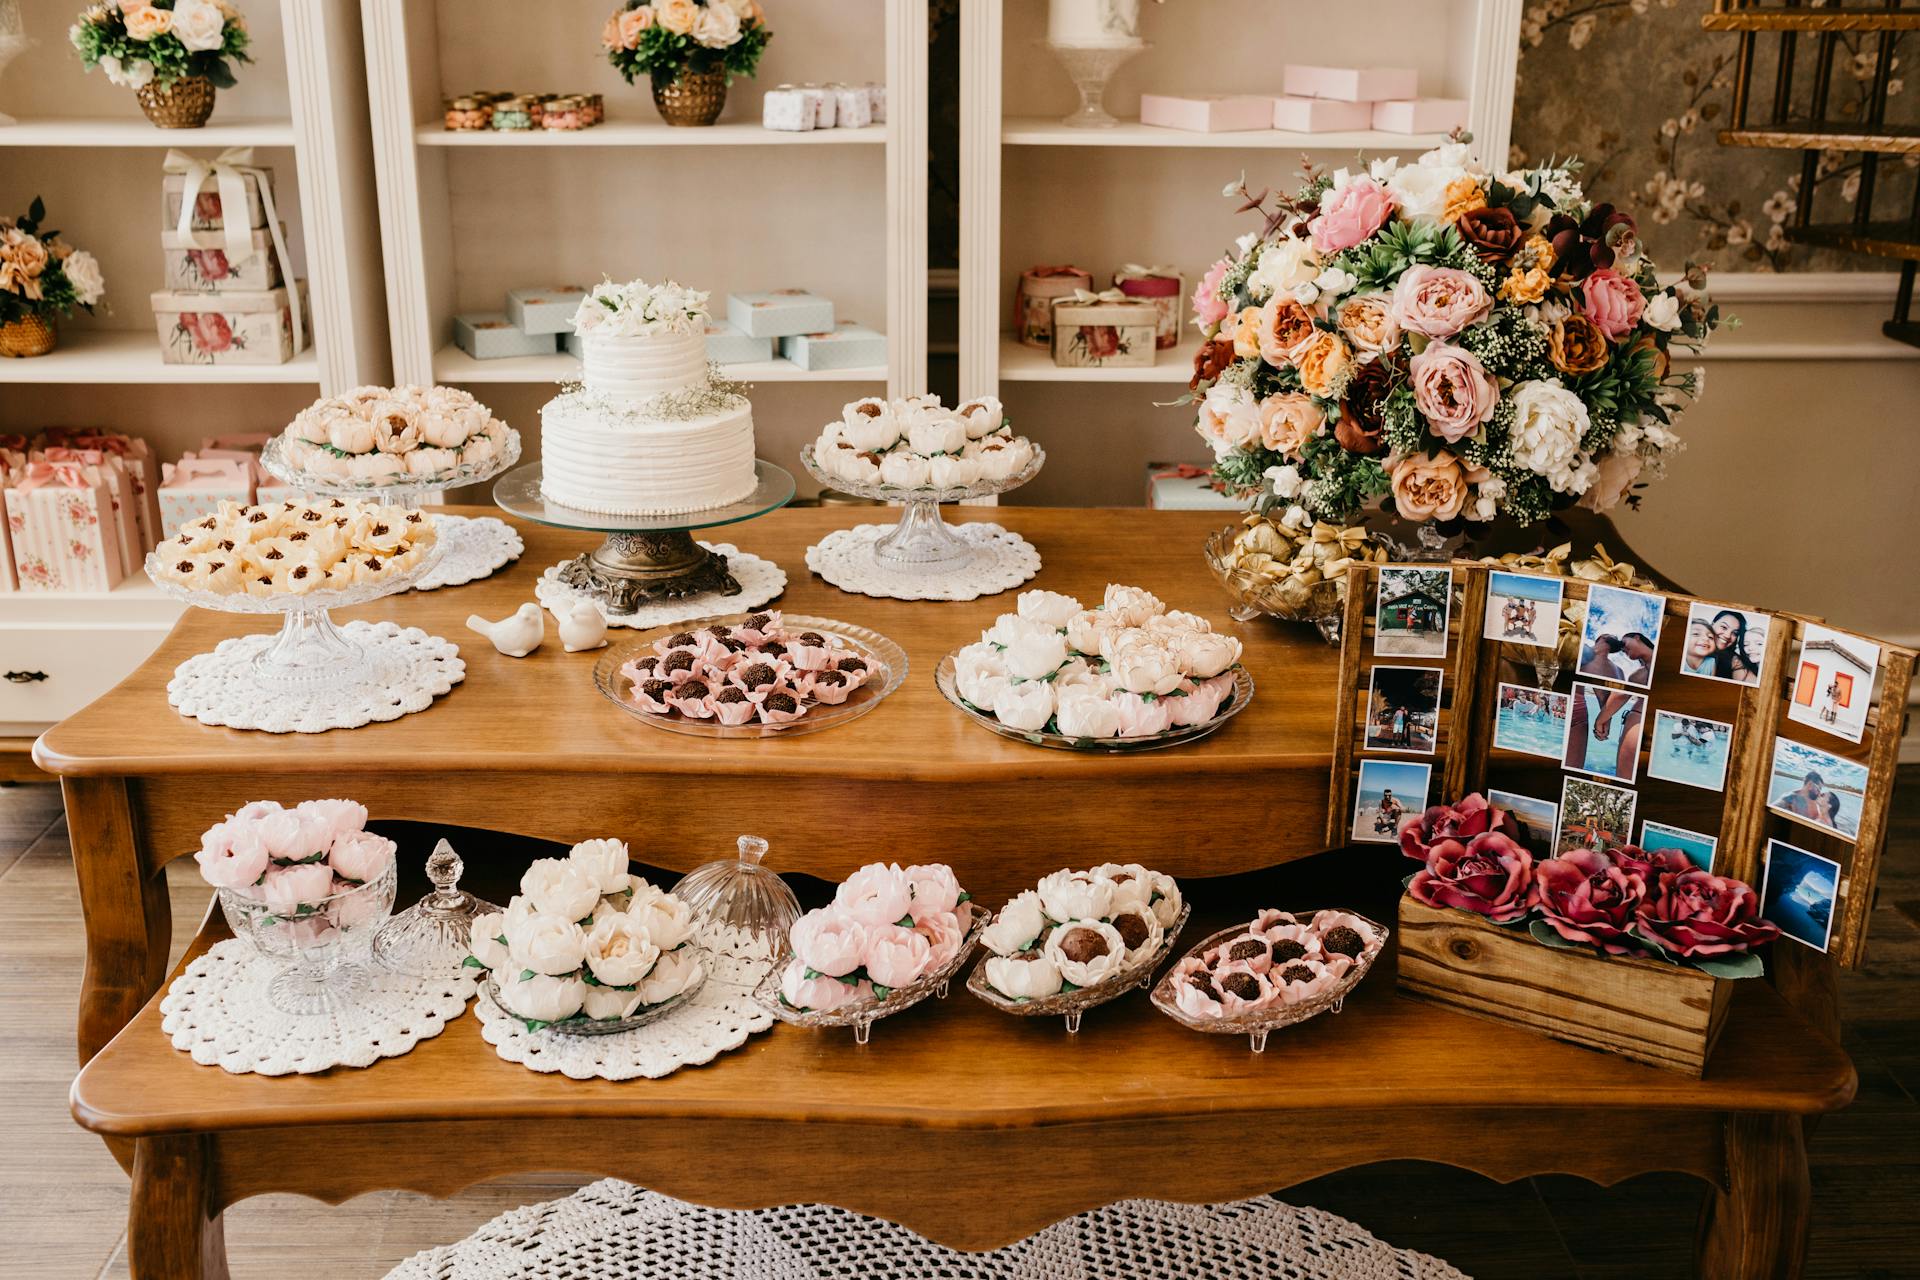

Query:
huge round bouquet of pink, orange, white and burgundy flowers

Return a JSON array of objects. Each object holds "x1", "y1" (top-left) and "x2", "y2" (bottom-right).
[{"x1": 1192, "y1": 136, "x2": 1720, "y2": 528}]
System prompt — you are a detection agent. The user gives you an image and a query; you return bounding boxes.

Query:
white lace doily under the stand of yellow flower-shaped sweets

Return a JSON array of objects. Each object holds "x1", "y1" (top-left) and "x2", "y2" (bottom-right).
[{"x1": 167, "y1": 622, "x2": 467, "y2": 733}]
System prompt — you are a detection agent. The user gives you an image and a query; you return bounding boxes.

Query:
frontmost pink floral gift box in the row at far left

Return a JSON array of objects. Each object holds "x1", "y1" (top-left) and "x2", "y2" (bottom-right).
[{"x1": 6, "y1": 462, "x2": 127, "y2": 591}]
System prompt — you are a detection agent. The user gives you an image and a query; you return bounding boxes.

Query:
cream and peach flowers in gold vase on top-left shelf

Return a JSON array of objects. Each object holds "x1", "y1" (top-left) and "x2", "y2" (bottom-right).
[{"x1": 67, "y1": 0, "x2": 253, "y2": 88}]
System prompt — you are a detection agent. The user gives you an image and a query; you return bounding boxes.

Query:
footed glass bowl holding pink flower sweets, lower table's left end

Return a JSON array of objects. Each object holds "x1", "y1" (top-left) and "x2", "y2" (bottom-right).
[{"x1": 219, "y1": 864, "x2": 396, "y2": 1017}]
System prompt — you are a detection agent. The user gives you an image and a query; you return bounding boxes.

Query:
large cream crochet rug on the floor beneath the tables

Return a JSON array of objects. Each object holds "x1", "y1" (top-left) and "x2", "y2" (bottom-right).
[{"x1": 386, "y1": 1178, "x2": 1467, "y2": 1280}]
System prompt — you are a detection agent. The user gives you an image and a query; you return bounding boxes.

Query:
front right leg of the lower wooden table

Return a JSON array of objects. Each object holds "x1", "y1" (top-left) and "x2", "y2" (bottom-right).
[{"x1": 1693, "y1": 1115, "x2": 1812, "y2": 1280}]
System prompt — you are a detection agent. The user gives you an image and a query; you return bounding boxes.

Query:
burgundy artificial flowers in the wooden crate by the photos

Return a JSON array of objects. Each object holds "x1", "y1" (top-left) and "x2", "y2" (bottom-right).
[{"x1": 1400, "y1": 794, "x2": 1780, "y2": 979}]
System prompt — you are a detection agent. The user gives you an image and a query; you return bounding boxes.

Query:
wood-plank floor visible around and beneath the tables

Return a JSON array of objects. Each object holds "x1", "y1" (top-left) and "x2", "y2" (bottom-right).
[{"x1": 0, "y1": 770, "x2": 1920, "y2": 1280}]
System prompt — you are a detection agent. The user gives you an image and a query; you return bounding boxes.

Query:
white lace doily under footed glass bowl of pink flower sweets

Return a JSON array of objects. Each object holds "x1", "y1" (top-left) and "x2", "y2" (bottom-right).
[{"x1": 159, "y1": 938, "x2": 474, "y2": 1075}]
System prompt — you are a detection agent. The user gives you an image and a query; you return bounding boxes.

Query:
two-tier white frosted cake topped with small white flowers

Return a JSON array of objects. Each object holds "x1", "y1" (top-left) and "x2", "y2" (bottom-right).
[{"x1": 540, "y1": 280, "x2": 756, "y2": 516}]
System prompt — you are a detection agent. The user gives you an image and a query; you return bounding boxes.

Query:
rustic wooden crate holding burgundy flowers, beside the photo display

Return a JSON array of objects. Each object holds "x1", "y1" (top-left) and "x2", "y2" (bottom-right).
[{"x1": 1398, "y1": 896, "x2": 1738, "y2": 1079}]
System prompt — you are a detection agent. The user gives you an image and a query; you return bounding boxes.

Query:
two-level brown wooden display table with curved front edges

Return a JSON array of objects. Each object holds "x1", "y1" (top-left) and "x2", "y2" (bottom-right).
[{"x1": 38, "y1": 509, "x2": 1855, "y2": 1278}]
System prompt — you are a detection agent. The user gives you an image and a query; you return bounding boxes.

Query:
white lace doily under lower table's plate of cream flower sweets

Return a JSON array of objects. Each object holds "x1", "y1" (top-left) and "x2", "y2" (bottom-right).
[{"x1": 474, "y1": 933, "x2": 774, "y2": 1080}]
